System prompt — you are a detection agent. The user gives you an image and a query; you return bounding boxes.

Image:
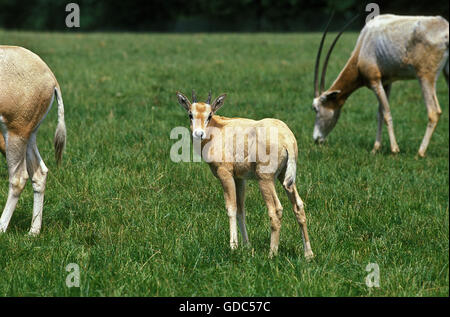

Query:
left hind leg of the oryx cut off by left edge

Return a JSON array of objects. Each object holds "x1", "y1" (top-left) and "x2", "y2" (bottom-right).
[{"x1": 0, "y1": 133, "x2": 28, "y2": 232}]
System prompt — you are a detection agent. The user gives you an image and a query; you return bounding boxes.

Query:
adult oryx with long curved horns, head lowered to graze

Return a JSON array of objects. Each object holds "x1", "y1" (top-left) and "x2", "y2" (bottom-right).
[{"x1": 313, "y1": 14, "x2": 448, "y2": 157}]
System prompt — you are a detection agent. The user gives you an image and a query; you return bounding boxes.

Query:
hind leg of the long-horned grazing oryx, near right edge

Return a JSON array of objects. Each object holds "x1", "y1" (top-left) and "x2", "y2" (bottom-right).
[{"x1": 418, "y1": 77, "x2": 442, "y2": 157}]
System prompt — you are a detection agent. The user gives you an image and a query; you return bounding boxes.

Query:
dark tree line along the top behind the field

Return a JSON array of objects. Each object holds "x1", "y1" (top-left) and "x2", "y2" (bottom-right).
[{"x1": 0, "y1": 0, "x2": 449, "y2": 32}]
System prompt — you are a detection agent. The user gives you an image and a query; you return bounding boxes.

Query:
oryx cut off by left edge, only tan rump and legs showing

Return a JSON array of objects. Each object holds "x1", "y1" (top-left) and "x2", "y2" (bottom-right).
[{"x1": 0, "y1": 46, "x2": 66, "y2": 235}]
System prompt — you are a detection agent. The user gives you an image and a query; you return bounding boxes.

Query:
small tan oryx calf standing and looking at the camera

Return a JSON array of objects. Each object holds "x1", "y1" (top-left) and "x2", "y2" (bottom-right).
[{"x1": 177, "y1": 92, "x2": 313, "y2": 259}]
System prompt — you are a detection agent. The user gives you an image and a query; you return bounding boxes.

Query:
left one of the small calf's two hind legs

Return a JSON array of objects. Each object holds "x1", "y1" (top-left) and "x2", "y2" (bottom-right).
[{"x1": 259, "y1": 180, "x2": 283, "y2": 257}]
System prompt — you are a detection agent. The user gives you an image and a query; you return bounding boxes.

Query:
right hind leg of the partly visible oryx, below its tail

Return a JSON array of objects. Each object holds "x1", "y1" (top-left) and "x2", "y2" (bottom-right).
[{"x1": 27, "y1": 132, "x2": 48, "y2": 235}]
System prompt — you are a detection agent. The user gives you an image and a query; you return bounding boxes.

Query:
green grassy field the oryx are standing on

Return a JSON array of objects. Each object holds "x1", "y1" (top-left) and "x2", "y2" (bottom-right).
[{"x1": 0, "y1": 30, "x2": 449, "y2": 296}]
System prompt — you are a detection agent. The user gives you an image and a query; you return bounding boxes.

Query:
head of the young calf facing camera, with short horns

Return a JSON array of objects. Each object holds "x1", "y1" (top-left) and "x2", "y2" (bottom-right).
[{"x1": 177, "y1": 91, "x2": 227, "y2": 140}]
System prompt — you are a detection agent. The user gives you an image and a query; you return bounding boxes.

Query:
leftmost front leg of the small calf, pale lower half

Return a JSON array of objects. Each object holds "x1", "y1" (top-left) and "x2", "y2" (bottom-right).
[{"x1": 217, "y1": 168, "x2": 238, "y2": 250}]
